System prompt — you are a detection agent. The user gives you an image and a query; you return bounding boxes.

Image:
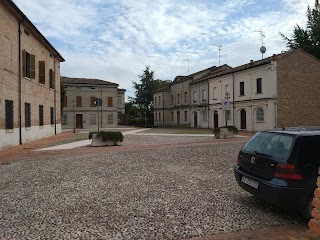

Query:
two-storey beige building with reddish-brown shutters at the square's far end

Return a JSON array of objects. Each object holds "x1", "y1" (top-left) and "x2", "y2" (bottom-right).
[{"x1": 61, "y1": 77, "x2": 125, "y2": 130}]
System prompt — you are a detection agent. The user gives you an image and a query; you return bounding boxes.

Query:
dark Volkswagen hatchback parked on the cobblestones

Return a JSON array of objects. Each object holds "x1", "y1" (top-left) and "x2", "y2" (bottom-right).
[{"x1": 234, "y1": 127, "x2": 320, "y2": 219}]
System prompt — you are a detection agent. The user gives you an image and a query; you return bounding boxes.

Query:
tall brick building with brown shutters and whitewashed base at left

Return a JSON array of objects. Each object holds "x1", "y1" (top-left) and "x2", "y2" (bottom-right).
[{"x1": 0, "y1": 0, "x2": 64, "y2": 148}]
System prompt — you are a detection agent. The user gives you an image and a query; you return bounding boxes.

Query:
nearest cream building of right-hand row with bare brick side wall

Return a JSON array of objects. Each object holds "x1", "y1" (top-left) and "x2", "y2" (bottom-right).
[{"x1": 208, "y1": 50, "x2": 320, "y2": 131}]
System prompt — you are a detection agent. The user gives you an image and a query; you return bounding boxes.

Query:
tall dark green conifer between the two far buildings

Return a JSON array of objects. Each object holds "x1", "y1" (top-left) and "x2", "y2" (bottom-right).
[{"x1": 129, "y1": 66, "x2": 170, "y2": 124}]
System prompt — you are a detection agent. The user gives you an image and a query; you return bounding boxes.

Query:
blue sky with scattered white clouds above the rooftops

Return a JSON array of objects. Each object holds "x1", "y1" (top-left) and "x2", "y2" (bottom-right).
[{"x1": 13, "y1": 0, "x2": 314, "y2": 96}]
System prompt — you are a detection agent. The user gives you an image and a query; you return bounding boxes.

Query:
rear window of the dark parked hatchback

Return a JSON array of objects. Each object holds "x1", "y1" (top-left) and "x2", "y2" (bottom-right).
[{"x1": 242, "y1": 132, "x2": 293, "y2": 160}]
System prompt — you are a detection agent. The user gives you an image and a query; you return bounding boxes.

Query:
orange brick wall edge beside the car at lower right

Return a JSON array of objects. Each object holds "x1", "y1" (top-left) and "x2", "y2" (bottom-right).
[{"x1": 309, "y1": 168, "x2": 320, "y2": 236}]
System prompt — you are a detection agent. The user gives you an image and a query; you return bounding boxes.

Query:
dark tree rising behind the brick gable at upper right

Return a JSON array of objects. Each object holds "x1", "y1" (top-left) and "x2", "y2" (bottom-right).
[{"x1": 280, "y1": 0, "x2": 320, "y2": 59}]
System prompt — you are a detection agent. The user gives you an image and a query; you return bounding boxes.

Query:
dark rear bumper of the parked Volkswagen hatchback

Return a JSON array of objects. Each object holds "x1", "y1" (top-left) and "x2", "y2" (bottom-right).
[{"x1": 234, "y1": 165, "x2": 308, "y2": 210}]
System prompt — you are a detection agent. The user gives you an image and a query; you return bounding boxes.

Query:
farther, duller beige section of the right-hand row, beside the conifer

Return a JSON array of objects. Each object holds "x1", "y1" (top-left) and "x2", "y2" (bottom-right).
[{"x1": 154, "y1": 65, "x2": 230, "y2": 128}]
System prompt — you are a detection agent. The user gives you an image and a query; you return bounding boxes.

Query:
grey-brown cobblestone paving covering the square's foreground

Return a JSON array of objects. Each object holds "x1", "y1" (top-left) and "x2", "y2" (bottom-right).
[{"x1": 0, "y1": 133, "x2": 307, "y2": 240}]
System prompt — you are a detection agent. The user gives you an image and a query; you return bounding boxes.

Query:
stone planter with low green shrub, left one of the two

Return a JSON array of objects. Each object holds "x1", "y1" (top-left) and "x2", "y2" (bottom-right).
[{"x1": 89, "y1": 131, "x2": 123, "y2": 147}]
